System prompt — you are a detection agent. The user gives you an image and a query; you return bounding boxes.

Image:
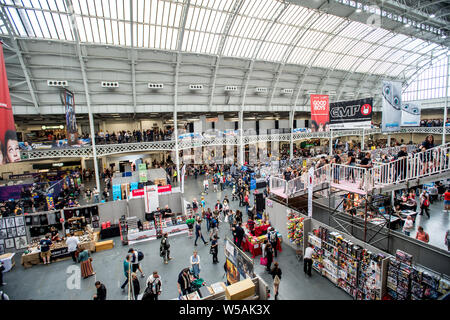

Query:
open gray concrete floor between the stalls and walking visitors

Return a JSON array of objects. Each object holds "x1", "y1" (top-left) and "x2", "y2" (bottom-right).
[{"x1": 2, "y1": 177, "x2": 351, "y2": 300}]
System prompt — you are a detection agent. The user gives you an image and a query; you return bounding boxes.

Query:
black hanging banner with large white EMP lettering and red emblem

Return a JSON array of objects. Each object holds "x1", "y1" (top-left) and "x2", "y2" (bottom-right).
[{"x1": 330, "y1": 98, "x2": 373, "y2": 129}]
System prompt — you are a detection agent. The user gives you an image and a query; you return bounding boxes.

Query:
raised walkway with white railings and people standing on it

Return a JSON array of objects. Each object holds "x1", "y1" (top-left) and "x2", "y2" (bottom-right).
[{"x1": 270, "y1": 143, "x2": 450, "y2": 199}]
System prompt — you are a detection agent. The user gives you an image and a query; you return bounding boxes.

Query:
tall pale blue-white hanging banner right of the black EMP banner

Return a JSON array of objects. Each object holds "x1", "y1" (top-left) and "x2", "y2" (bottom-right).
[{"x1": 381, "y1": 81, "x2": 402, "y2": 132}]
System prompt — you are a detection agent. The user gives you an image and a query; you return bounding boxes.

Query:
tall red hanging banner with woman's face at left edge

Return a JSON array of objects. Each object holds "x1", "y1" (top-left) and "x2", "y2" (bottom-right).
[{"x1": 0, "y1": 41, "x2": 20, "y2": 164}]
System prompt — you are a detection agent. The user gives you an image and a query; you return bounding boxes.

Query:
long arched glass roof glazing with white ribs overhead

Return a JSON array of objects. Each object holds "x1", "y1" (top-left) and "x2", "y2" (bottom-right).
[{"x1": 0, "y1": 0, "x2": 447, "y2": 79}]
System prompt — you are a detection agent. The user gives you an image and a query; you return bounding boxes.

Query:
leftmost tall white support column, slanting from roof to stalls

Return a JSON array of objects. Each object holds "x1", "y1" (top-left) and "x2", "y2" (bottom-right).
[{"x1": 66, "y1": 0, "x2": 101, "y2": 192}]
